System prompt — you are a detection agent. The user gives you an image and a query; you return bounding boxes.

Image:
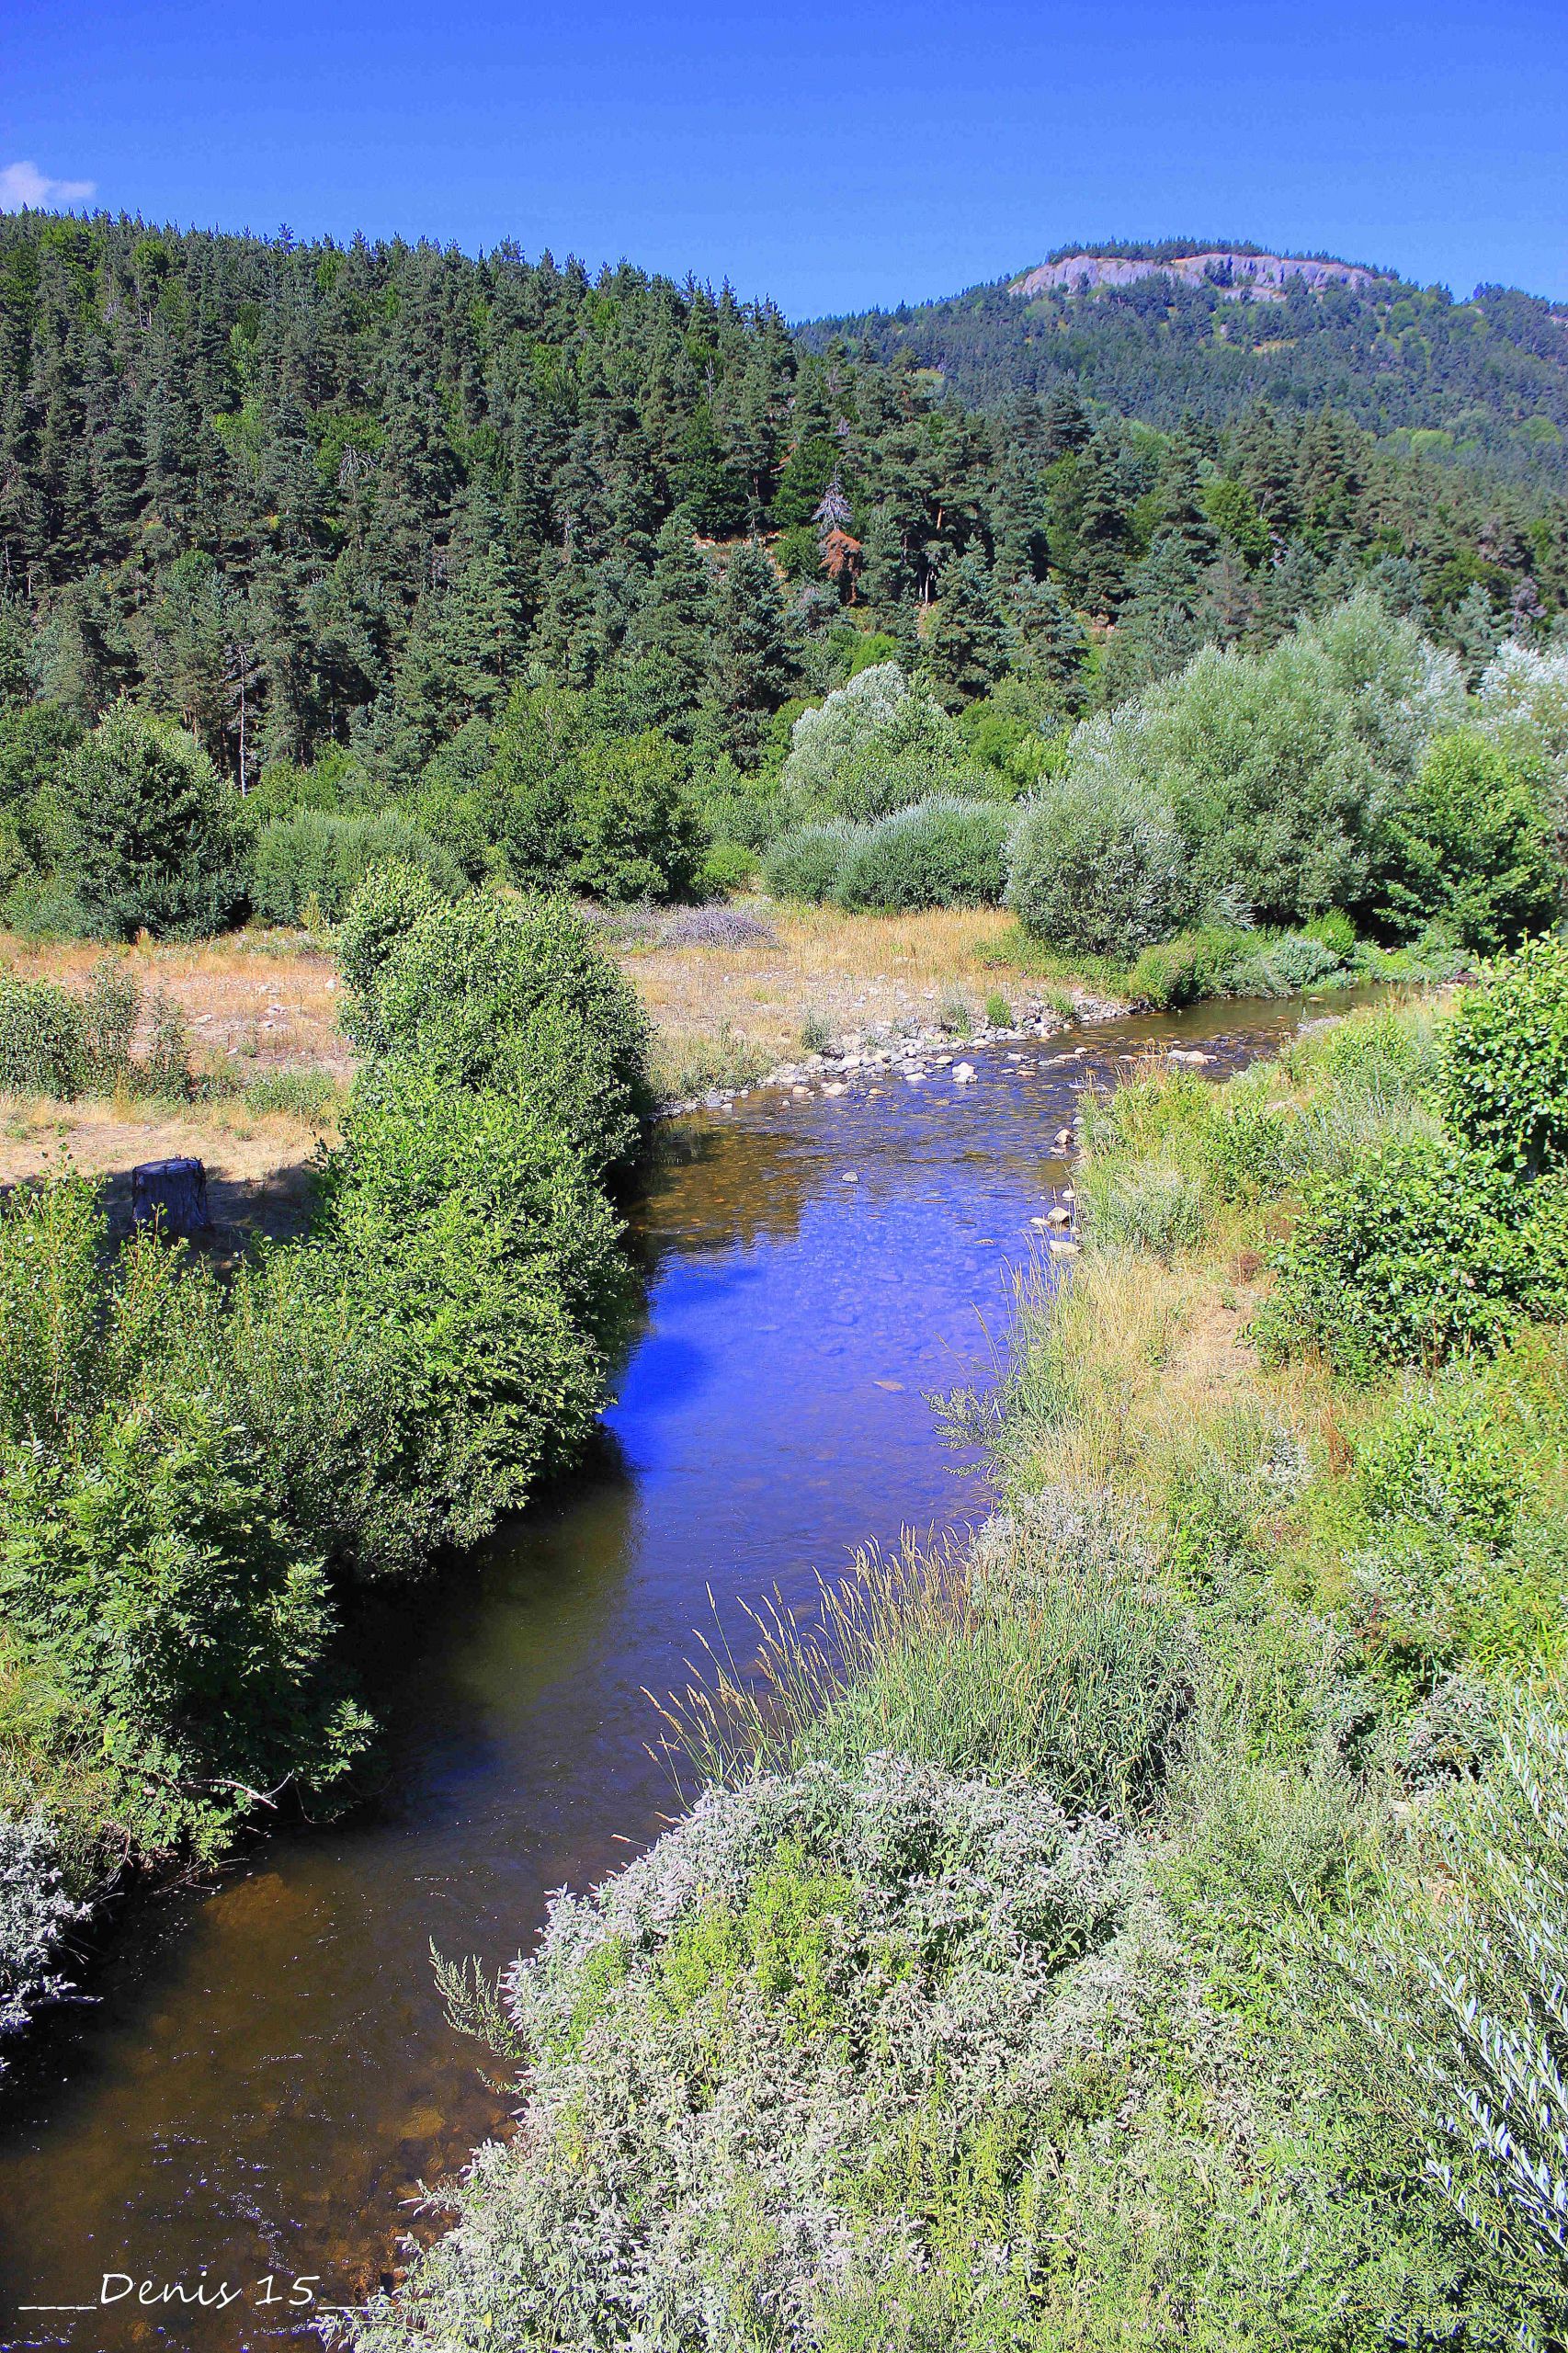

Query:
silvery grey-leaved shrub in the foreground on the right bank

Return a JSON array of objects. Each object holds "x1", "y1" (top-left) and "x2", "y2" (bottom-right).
[{"x1": 341, "y1": 1756, "x2": 1125, "y2": 2353}]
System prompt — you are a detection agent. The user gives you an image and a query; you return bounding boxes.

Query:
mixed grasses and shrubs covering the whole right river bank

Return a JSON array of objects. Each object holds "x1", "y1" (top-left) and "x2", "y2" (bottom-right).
[{"x1": 339, "y1": 941, "x2": 1568, "y2": 2353}]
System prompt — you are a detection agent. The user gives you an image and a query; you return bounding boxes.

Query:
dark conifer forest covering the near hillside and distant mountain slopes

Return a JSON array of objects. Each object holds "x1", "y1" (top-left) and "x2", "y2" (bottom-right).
[{"x1": 0, "y1": 214, "x2": 1568, "y2": 856}]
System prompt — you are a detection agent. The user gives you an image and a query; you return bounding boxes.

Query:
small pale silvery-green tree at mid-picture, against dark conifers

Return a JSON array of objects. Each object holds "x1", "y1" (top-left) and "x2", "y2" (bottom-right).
[{"x1": 779, "y1": 661, "x2": 972, "y2": 819}]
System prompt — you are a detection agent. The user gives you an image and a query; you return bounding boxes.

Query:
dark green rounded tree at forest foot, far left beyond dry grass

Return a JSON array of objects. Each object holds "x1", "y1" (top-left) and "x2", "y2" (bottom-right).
[{"x1": 59, "y1": 701, "x2": 240, "y2": 938}]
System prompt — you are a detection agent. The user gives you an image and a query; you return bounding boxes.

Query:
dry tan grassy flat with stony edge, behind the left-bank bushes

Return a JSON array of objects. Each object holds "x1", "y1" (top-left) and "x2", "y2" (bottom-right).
[{"x1": 0, "y1": 906, "x2": 1125, "y2": 1252}]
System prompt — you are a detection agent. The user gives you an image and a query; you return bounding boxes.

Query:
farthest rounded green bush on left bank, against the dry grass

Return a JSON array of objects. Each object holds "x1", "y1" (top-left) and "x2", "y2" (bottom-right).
[{"x1": 344, "y1": 866, "x2": 650, "y2": 1174}]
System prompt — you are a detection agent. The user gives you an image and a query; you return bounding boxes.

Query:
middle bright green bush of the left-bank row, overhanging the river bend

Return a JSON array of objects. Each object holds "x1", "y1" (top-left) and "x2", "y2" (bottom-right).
[{"x1": 313, "y1": 1056, "x2": 633, "y2": 1543}]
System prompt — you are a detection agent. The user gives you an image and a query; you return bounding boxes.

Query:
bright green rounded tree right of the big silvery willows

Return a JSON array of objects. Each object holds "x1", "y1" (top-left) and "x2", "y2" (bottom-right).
[{"x1": 1378, "y1": 732, "x2": 1561, "y2": 955}]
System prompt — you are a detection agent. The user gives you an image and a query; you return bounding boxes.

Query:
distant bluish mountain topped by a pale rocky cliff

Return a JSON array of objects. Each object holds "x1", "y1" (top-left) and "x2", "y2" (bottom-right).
[{"x1": 801, "y1": 238, "x2": 1568, "y2": 480}]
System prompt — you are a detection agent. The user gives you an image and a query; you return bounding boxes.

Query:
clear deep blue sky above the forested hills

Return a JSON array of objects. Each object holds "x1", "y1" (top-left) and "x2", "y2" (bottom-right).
[{"x1": 0, "y1": 0, "x2": 1568, "y2": 318}]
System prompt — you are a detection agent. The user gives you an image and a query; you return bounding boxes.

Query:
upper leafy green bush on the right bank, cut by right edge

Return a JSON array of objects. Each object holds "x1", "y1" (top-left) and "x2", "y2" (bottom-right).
[{"x1": 1441, "y1": 938, "x2": 1568, "y2": 1176}]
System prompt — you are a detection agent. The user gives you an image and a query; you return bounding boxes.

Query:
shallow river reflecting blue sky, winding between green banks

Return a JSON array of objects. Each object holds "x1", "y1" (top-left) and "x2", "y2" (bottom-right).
[{"x1": 0, "y1": 1005, "x2": 1346, "y2": 2353}]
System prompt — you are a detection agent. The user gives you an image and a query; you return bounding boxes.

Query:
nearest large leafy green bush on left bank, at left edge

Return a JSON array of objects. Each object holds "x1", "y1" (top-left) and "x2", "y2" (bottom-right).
[{"x1": 0, "y1": 1395, "x2": 365, "y2": 1854}]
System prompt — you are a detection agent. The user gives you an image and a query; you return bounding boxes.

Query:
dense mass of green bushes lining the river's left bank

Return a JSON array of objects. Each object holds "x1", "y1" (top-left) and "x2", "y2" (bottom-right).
[{"x1": 0, "y1": 866, "x2": 647, "y2": 2007}]
